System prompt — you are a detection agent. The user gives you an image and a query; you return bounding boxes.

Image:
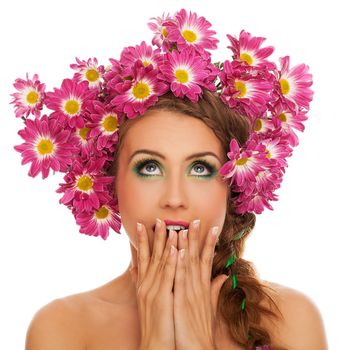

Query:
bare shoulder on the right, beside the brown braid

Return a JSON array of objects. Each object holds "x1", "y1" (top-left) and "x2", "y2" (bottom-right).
[{"x1": 268, "y1": 282, "x2": 328, "y2": 350}]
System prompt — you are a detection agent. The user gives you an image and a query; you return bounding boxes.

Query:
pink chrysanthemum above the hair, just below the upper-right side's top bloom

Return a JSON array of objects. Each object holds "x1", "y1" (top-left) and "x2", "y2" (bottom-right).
[{"x1": 219, "y1": 61, "x2": 273, "y2": 116}]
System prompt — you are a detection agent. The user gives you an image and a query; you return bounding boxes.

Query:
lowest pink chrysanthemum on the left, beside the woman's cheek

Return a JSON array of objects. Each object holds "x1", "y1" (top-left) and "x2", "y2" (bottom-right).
[{"x1": 75, "y1": 201, "x2": 121, "y2": 240}]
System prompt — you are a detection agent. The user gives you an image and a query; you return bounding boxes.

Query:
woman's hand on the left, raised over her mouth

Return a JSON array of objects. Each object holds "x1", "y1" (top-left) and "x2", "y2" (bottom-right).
[{"x1": 132, "y1": 220, "x2": 178, "y2": 350}]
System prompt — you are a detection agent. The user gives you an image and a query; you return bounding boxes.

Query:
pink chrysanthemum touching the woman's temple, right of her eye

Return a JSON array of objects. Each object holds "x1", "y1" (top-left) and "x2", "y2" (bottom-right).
[{"x1": 220, "y1": 139, "x2": 268, "y2": 189}]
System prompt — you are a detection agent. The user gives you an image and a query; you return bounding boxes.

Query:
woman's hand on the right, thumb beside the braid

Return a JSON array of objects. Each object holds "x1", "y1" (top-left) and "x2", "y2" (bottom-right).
[{"x1": 174, "y1": 222, "x2": 228, "y2": 350}]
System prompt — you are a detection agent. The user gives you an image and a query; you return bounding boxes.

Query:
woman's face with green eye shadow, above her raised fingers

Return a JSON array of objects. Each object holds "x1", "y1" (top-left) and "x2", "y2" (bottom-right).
[{"x1": 116, "y1": 110, "x2": 228, "y2": 251}]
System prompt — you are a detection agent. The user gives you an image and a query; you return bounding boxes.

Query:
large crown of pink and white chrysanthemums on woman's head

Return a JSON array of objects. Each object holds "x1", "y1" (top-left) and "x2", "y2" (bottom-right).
[{"x1": 11, "y1": 9, "x2": 313, "y2": 239}]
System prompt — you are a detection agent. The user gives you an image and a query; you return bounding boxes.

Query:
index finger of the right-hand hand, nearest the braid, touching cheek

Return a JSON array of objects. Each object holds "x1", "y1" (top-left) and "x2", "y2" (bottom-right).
[{"x1": 200, "y1": 226, "x2": 219, "y2": 285}]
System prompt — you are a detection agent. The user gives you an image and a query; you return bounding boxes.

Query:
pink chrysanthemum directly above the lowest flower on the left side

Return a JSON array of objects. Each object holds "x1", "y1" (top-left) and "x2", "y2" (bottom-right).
[{"x1": 56, "y1": 158, "x2": 114, "y2": 212}]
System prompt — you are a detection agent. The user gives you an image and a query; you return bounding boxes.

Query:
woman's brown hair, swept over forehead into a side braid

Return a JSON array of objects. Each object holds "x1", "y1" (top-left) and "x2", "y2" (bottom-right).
[{"x1": 110, "y1": 90, "x2": 285, "y2": 350}]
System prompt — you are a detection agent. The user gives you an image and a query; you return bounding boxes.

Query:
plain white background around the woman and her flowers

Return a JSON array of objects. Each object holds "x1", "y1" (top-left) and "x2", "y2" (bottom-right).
[{"x1": 0, "y1": 0, "x2": 350, "y2": 350}]
